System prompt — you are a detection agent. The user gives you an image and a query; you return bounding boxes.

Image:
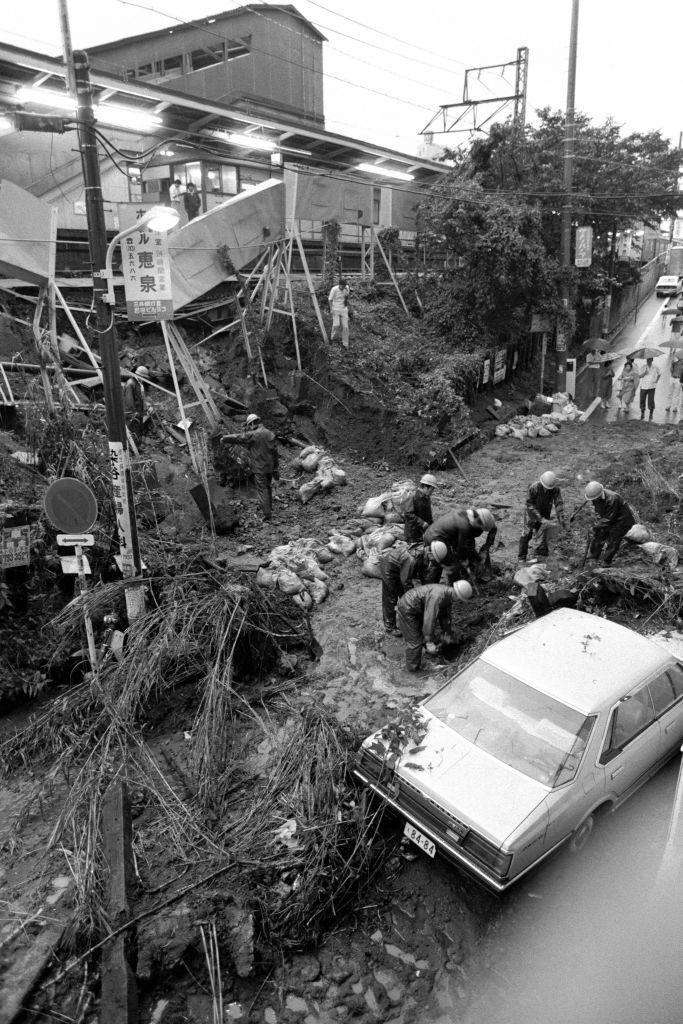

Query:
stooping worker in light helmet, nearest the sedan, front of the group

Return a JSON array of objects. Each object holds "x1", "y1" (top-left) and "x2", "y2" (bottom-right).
[{"x1": 396, "y1": 580, "x2": 472, "y2": 672}]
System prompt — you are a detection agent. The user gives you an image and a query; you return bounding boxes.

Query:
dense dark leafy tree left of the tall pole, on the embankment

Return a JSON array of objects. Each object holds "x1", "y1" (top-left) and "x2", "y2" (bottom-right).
[{"x1": 420, "y1": 180, "x2": 559, "y2": 351}]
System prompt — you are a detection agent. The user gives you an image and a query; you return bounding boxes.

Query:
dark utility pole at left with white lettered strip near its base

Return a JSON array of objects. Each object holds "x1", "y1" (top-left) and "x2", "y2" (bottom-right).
[{"x1": 74, "y1": 50, "x2": 144, "y2": 620}]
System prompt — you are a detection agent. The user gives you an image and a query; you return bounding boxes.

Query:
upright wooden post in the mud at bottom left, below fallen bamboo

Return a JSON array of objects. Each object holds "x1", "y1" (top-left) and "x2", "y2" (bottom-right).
[{"x1": 99, "y1": 777, "x2": 139, "y2": 1024}]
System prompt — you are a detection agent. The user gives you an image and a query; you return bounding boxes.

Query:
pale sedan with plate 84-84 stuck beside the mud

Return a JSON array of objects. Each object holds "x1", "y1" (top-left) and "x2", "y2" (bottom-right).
[{"x1": 354, "y1": 608, "x2": 683, "y2": 892}]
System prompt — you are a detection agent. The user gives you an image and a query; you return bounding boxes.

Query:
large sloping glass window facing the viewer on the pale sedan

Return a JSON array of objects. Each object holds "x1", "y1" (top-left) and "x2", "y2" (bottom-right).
[{"x1": 425, "y1": 658, "x2": 595, "y2": 787}]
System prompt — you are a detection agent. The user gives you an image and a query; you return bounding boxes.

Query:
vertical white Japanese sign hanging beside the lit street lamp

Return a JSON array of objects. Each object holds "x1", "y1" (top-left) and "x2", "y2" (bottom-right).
[{"x1": 122, "y1": 227, "x2": 173, "y2": 321}]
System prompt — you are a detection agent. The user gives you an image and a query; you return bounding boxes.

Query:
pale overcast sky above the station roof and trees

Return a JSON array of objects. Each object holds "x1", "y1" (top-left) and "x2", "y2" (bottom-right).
[{"x1": 0, "y1": 0, "x2": 683, "y2": 153}]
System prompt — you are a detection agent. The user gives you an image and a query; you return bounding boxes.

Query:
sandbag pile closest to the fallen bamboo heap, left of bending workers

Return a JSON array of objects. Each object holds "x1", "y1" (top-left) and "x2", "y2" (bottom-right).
[{"x1": 256, "y1": 537, "x2": 334, "y2": 609}]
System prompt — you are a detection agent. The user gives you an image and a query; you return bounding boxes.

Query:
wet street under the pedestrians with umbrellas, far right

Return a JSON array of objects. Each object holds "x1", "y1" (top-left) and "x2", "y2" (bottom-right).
[{"x1": 577, "y1": 294, "x2": 683, "y2": 424}]
